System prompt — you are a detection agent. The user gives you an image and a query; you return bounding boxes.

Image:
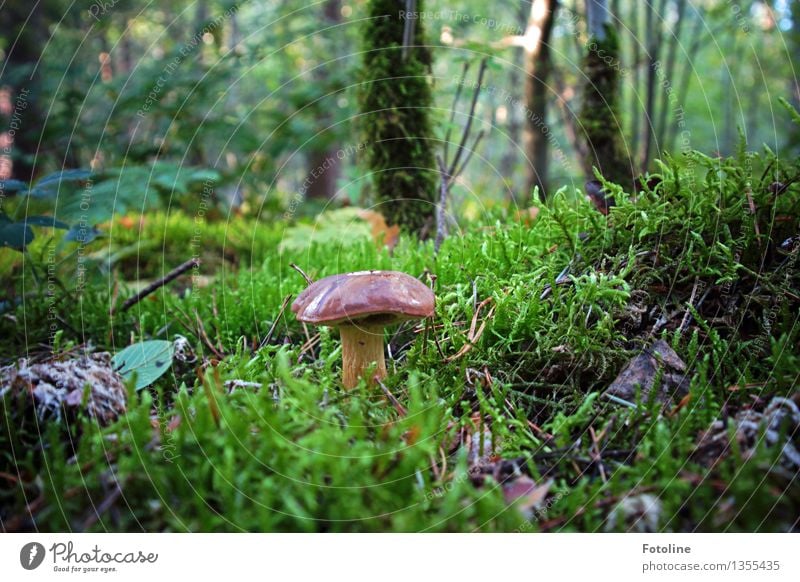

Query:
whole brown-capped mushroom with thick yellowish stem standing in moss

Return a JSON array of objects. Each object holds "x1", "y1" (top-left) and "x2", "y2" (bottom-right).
[{"x1": 292, "y1": 271, "x2": 434, "y2": 389}]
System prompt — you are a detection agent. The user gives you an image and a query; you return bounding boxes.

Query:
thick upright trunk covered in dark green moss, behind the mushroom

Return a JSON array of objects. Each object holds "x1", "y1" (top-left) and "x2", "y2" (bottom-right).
[{"x1": 359, "y1": 0, "x2": 437, "y2": 236}]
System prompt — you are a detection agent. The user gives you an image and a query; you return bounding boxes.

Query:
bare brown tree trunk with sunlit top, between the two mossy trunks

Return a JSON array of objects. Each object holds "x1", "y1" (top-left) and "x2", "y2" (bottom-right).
[{"x1": 524, "y1": 0, "x2": 558, "y2": 200}]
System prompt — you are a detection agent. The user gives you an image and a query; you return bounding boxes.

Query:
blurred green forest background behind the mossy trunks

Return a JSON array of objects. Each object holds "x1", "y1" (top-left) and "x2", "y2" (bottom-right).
[{"x1": 0, "y1": 0, "x2": 800, "y2": 220}]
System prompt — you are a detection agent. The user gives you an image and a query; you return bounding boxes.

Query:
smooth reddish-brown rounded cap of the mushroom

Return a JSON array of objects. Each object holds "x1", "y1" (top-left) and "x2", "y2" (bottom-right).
[{"x1": 292, "y1": 271, "x2": 435, "y2": 325}]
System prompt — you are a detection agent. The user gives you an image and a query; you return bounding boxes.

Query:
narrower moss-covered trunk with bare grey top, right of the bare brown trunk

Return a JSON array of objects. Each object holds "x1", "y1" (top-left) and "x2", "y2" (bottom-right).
[{"x1": 580, "y1": 0, "x2": 632, "y2": 188}]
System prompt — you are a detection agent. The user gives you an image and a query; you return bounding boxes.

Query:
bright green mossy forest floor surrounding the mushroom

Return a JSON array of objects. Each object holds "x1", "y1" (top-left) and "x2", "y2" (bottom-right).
[{"x1": 0, "y1": 147, "x2": 800, "y2": 532}]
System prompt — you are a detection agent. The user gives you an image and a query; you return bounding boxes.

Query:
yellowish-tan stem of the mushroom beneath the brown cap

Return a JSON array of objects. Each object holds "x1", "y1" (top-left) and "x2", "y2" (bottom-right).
[{"x1": 339, "y1": 324, "x2": 386, "y2": 390}]
